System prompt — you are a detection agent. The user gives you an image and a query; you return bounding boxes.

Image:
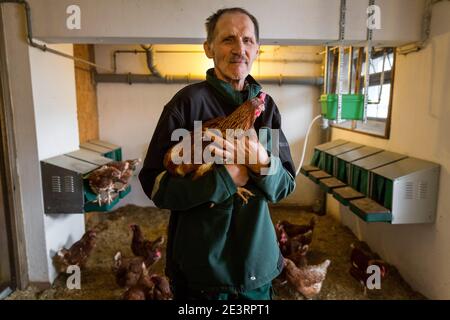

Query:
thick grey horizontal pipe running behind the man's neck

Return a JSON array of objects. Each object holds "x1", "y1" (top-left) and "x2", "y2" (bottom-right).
[{"x1": 95, "y1": 73, "x2": 323, "y2": 86}]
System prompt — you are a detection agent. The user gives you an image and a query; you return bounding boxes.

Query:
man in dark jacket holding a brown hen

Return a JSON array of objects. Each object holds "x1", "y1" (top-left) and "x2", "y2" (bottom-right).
[{"x1": 139, "y1": 8, "x2": 295, "y2": 300}]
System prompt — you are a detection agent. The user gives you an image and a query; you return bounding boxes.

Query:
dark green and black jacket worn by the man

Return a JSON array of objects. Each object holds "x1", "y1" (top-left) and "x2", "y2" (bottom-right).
[{"x1": 139, "y1": 71, "x2": 295, "y2": 292}]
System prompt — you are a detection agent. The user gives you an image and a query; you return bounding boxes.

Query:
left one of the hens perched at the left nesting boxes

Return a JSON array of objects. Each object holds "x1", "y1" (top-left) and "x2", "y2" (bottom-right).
[{"x1": 87, "y1": 165, "x2": 121, "y2": 205}]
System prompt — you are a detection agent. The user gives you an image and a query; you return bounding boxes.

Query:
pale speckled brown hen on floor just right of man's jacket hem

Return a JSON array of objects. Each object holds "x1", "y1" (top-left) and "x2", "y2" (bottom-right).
[{"x1": 284, "y1": 258, "x2": 331, "y2": 299}]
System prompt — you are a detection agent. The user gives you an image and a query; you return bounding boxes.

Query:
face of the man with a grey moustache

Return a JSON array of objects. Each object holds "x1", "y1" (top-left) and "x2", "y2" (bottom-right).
[{"x1": 203, "y1": 12, "x2": 259, "y2": 85}]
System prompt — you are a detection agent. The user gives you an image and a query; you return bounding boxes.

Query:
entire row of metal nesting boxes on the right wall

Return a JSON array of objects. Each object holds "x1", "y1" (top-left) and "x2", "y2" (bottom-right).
[{"x1": 301, "y1": 140, "x2": 440, "y2": 224}]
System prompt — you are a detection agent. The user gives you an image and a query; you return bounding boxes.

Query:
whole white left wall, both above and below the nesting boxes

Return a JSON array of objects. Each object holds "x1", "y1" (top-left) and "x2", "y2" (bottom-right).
[{"x1": 29, "y1": 44, "x2": 84, "y2": 282}]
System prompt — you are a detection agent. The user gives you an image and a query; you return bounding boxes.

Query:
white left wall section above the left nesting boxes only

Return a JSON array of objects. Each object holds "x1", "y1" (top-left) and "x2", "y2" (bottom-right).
[{"x1": 30, "y1": 44, "x2": 79, "y2": 160}]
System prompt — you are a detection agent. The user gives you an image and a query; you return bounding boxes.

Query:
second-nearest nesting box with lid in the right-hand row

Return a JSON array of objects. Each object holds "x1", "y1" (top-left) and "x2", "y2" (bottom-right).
[{"x1": 350, "y1": 151, "x2": 407, "y2": 195}]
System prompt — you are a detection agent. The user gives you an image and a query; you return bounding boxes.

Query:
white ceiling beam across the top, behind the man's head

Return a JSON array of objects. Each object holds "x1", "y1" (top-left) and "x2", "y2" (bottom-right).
[{"x1": 29, "y1": 0, "x2": 425, "y2": 45}]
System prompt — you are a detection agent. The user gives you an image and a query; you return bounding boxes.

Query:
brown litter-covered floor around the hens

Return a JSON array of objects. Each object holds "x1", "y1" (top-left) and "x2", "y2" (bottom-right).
[{"x1": 8, "y1": 205, "x2": 424, "y2": 300}]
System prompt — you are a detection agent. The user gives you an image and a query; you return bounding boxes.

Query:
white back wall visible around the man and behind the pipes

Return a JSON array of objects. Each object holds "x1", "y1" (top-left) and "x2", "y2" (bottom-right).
[{"x1": 95, "y1": 45, "x2": 321, "y2": 205}]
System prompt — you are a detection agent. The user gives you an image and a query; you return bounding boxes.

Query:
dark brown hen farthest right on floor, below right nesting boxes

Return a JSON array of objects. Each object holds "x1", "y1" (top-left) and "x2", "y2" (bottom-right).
[{"x1": 349, "y1": 243, "x2": 388, "y2": 295}]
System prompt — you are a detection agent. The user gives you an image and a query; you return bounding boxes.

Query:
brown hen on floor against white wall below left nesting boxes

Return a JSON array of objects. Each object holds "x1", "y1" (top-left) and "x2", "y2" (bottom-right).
[{"x1": 53, "y1": 230, "x2": 97, "y2": 272}]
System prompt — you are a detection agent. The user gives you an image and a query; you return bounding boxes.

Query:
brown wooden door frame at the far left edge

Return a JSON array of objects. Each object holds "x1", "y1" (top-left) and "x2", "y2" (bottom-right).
[{"x1": 0, "y1": 7, "x2": 29, "y2": 290}]
